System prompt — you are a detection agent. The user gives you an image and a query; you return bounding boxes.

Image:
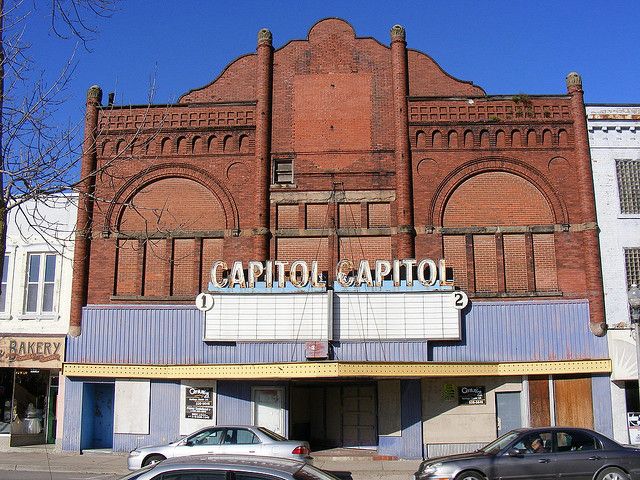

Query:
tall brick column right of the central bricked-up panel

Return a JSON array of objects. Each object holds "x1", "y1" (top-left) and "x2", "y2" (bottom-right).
[{"x1": 391, "y1": 25, "x2": 415, "y2": 258}]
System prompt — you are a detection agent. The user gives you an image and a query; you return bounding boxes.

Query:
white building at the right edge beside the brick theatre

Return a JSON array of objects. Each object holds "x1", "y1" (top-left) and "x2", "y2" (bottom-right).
[{"x1": 587, "y1": 105, "x2": 640, "y2": 443}]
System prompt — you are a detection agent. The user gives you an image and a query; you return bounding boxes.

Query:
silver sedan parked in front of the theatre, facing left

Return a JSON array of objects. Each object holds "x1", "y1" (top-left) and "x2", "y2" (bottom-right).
[{"x1": 127, "y1": 425, "x2": 312, "y2": 470}]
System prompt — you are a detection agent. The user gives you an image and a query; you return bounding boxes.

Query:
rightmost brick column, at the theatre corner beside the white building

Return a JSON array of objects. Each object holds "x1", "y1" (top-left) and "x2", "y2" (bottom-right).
[{"x1": 567, "y1": 72, "x2": 606, "y2": 337}]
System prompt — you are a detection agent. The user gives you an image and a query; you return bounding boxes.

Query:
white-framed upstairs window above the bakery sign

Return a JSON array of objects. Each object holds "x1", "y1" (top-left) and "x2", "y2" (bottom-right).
[{"x1": 25, "y1": 253, "x2": 56, "y2": 313}]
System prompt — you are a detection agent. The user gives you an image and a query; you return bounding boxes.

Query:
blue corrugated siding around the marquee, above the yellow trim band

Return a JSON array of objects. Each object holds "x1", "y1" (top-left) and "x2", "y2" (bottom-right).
[{"x1": 66, "y1": 300, "x2": 608, "y2": 365}]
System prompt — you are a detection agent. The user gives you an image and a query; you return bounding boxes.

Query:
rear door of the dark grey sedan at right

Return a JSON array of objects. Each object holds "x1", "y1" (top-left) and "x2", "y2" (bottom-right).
[{"x1": 555, "y1": 429, "x2": 607, "y2": 480}]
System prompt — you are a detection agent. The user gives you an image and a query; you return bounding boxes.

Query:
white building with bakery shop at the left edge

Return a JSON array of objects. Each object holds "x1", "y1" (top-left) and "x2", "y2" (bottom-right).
[{"x1": 0, "y1": 195, "x2": 77, "y2": 447}]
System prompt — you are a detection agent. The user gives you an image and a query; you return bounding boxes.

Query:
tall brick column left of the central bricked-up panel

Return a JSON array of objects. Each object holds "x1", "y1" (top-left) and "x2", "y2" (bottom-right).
[{"x1": 253, "y1": 28, "x2": 273, "y2": 260}]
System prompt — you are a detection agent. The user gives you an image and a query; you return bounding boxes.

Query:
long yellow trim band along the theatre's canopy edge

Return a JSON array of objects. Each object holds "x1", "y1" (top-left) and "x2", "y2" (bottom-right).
[{"x1": 62, "y1": 359, "x2": 611, "y2": 380}]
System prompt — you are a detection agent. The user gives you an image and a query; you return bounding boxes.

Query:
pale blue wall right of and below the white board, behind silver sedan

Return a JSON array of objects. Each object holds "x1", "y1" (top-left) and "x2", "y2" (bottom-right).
[{"x1": 113, "y1": 380, "x2": 180, "y2": 452}]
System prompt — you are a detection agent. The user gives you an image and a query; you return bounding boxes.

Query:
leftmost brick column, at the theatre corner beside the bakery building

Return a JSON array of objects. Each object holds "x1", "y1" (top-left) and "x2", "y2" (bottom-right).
[{"x1": 69, "y1": 85, "x2": 102, "y2": 337}]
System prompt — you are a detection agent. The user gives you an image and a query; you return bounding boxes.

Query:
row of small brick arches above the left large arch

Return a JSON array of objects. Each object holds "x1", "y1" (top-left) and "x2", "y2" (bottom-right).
[{"x1": 100, "y1": 134, "x2": 253, "y2": 156}]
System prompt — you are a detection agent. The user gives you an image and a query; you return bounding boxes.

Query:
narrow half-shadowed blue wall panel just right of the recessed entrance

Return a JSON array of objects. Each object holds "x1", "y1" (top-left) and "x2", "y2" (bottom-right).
[{"x1": 399, "y1": 380, "x2": 422, "y2": 459}]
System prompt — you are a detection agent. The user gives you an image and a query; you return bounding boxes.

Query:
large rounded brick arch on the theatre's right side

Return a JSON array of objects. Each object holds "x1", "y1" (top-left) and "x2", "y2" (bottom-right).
[{"x1": 426, "y1": 157, "x2": 569, "y2": 227}]
